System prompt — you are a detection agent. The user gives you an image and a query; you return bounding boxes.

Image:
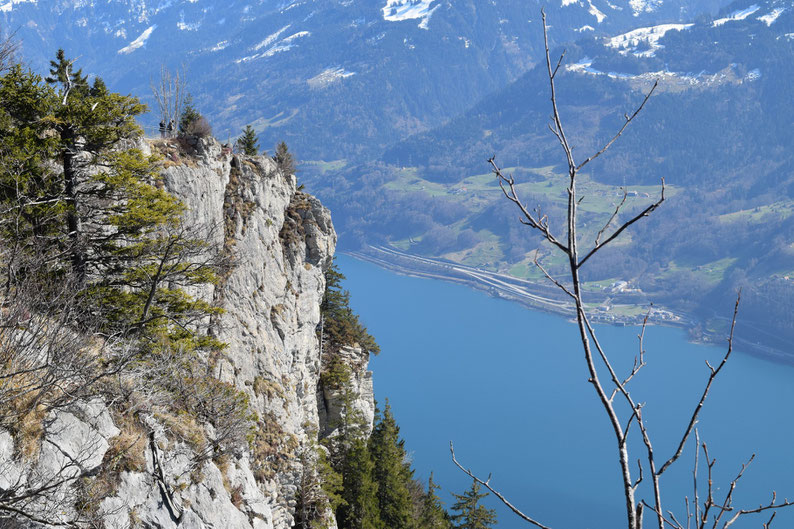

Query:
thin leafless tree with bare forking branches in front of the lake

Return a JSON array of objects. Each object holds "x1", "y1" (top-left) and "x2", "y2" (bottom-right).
[{"x1": 450, "y1": 12, "x2": 792, "y2": 529}]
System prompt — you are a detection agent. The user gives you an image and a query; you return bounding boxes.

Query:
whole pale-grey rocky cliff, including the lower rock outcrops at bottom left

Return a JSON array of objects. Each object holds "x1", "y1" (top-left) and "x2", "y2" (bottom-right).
[{"x1": 0, "y1": 138, "x2": 374, "y2": 529}]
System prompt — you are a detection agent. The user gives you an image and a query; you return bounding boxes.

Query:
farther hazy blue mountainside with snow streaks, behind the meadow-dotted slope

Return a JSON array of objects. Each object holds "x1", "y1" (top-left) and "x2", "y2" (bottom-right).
[{"x1": 0, "y1": 0, "x2": 725, "y2": 159}]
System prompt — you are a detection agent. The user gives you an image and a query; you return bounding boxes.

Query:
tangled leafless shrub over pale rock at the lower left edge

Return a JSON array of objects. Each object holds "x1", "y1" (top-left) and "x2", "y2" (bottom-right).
[{"x1": 0, "y1": 243, "x2": 133, "y2": 527}]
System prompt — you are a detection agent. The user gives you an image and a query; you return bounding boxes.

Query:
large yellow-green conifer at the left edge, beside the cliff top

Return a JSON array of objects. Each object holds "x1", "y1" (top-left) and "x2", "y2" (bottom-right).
[{"x1": 0, "y1": 52, "x2": 220, "y2": 346}]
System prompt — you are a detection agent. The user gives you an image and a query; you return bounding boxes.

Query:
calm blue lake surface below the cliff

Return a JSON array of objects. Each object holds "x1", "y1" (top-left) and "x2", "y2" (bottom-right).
[{"x1": 338, "y1": 255, "x2": 794, "y2": 529}]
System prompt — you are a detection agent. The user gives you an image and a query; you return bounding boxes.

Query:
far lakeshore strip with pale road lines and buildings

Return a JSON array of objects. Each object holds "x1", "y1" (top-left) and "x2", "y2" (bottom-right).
[{"x1": 341, "y1": 245, "x2": 794, "y2": 365}]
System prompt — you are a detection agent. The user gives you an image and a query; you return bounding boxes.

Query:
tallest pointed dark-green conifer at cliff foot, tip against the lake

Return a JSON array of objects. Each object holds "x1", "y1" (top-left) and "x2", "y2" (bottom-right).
[{"x1": 369, "y1": 402, "x2": 413, "y2": 529}]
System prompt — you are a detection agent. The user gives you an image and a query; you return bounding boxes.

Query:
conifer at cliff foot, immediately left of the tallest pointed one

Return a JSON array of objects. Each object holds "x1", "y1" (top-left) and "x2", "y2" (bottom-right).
[{"x1": 336, "y1": 439, "x2": 382, "y2": 529}]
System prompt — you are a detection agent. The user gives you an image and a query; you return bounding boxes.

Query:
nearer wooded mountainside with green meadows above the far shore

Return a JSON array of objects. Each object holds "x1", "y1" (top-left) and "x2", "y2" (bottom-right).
[{"x1": 310, "y1": 1, "x2": 794, "y2": 349}]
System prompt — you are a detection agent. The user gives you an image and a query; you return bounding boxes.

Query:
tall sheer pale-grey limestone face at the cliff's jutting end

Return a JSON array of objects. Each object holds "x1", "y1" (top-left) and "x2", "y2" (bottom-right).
[{"x1": 159, "y1": 136, "x2": 336, "y2": 528}]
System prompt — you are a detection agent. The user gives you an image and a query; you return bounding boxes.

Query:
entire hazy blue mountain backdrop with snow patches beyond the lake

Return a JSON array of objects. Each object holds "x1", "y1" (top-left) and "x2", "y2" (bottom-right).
[{"x1": 6, "y1": 0, "x2": 794, "y2": 351}]
